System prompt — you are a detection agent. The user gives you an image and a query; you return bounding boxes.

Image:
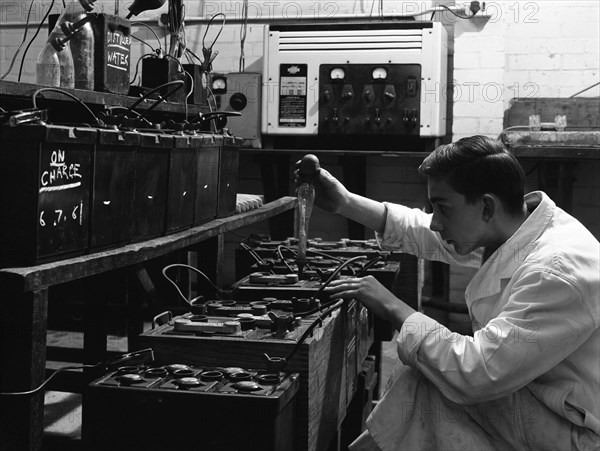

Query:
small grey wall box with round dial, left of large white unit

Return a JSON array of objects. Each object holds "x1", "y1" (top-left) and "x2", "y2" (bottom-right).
[{"x1": 212, "y1": 72, "x2": 262, "y2": 148}]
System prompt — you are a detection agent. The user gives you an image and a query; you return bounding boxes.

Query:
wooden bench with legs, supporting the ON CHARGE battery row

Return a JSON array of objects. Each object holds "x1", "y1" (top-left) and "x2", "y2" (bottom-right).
[{"x1": 0, "y1": 197, "x2": 296, "y2": 451}]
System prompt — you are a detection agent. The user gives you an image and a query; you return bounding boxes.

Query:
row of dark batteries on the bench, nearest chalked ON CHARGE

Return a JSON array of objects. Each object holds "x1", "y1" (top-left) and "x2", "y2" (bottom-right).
[{"x1": 0, "y1": 124, "x2": 241, "y2": 267}]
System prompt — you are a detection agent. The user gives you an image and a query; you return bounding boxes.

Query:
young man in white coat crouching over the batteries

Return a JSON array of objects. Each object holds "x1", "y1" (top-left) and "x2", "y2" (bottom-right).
[{"x1": 316, "y1": 136, "x2": 600, "y2": 451}]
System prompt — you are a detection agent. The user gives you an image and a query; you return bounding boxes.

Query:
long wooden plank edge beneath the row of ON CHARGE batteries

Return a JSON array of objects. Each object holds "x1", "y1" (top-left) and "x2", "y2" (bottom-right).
[{"x1": 0, "y1": 197, "x2": 296, "y2": 293}]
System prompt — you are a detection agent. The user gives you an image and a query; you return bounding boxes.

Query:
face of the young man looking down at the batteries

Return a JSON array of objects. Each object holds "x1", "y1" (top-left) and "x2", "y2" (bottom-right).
[{"x1": 427, "y1": 177, "x2": 486, "y2": 255}]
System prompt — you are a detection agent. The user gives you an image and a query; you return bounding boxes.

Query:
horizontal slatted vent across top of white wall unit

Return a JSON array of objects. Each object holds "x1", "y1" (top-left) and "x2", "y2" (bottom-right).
[{"x1": 279, "y1": 29, "x2": 423, "y2": 53}]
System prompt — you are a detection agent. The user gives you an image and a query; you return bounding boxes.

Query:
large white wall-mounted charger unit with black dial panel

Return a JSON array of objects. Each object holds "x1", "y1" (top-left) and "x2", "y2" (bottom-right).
[{"x1": 262, "y1": 21, "x2": 447, "y2": 137}]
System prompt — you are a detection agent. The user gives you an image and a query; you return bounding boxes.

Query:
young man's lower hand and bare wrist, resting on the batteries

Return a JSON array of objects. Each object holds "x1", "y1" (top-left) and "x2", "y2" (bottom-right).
[{"x1": 324, "y1": 276, "x2": 416, "y2": 330}]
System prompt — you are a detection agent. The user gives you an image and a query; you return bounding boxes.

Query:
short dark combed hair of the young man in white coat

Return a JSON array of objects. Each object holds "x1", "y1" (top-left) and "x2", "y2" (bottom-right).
[{"x1": 419, "y1": 135, "x2": 525, "y2": 214}]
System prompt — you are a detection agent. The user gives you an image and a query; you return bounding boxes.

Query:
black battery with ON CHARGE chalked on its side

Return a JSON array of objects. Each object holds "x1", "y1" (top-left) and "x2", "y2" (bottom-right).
[{"x1": 0, "y1": 125, "x2": 96, "y2": 266}]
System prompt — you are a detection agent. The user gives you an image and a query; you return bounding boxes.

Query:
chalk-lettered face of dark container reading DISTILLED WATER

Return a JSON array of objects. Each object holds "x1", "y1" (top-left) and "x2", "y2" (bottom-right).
[{"x1": 94, "y1": 14, "x2": 131, "y2": 94}]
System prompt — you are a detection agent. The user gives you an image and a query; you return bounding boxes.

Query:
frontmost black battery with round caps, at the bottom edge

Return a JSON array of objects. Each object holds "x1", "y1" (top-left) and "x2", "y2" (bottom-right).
[{"x1": 82, "y1": 362, "x2": 299, "y2": 451}]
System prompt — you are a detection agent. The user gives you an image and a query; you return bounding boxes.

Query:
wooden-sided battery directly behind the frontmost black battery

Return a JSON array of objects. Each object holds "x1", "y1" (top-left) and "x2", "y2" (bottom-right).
[{"x1": 138, "y1": 297, "x2": 373, "y2": 451}]
